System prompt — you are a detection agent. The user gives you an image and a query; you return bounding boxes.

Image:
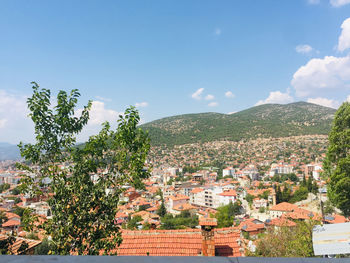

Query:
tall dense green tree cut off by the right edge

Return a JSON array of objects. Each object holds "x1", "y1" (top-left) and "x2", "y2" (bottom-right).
[{"x1": 323, "y1": 102, "x2": 350, "y2": 216}]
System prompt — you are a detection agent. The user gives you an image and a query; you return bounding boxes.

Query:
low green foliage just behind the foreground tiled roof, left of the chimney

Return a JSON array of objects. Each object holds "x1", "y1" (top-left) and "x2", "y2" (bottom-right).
[{"x1": 160, "y1": 211, "x2": 198, "y2": 229}]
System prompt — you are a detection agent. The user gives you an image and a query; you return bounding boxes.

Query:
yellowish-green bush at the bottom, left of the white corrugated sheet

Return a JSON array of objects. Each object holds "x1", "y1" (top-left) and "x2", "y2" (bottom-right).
[{"x1": 252, "y1": 221, "x2": 318, "y2": 257}]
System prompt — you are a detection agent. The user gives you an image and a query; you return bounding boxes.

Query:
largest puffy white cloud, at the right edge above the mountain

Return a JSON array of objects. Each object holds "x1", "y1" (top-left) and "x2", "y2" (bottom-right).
[{"x1": 291, "y1": 56, "x2": 350, "y2": 97}]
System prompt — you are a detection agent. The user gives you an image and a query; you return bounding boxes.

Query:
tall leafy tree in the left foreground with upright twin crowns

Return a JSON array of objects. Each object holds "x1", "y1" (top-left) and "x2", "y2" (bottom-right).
[{"x1": 17, "y1": 82, "x2": 150, "y2": 255}]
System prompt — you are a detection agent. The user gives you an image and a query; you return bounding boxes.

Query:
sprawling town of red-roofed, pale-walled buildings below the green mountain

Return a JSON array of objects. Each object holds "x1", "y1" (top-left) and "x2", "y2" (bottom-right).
[{"x1": 0, "y1": 135, "x2": 348, "y2": 256}]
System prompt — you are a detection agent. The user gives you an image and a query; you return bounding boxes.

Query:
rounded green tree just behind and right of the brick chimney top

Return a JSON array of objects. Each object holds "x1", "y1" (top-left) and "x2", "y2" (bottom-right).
[{"x1": 215, "y1": 202, "x2": 242, "y2": 227}]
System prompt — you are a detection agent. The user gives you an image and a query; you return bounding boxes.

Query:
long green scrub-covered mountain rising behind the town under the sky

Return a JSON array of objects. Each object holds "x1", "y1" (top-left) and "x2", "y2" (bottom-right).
[{"x1": 140, "y1": 102, "x2": 336, "y2": 146}]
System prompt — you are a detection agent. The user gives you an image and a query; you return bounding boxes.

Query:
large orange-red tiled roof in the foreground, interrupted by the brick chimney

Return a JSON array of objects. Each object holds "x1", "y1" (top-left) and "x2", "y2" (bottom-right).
[{"x1": 117, "y1": 228, "x2": 242, "y2": 257}]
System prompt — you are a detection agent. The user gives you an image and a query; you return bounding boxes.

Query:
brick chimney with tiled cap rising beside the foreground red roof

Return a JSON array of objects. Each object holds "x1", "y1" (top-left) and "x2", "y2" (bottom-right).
[{"x1": 199, "y1": 218, "x2": 217, "y2": 257}]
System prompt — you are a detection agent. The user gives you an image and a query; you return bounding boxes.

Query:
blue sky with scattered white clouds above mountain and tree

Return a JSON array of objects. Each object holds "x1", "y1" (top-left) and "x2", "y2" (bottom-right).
[{"x1": 0, "y1": 0, "x2": 350, "y2": 144}]
